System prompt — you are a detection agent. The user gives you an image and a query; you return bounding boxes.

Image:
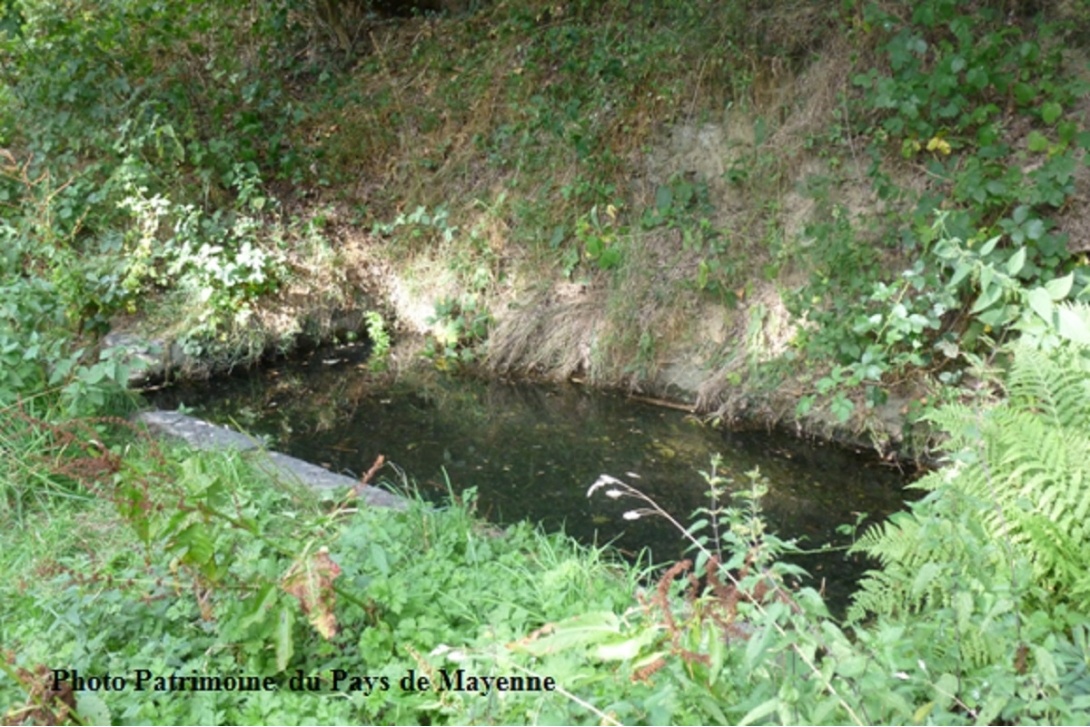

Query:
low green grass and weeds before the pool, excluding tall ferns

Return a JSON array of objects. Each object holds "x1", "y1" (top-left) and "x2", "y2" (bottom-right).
[{"x1": 0, "y1": 392, "x2": 1090, "y2": 724}]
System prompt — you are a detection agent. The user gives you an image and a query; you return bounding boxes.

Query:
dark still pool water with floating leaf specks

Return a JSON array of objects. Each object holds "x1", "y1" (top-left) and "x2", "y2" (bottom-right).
[{"x1": 155, "y1": 351, "x2": 907, "y2": 610}]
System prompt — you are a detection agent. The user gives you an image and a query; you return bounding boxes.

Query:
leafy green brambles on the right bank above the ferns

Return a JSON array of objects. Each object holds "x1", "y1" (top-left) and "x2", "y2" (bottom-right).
[{"x1": 787, "y1": 0, "x2": 1090, "y2": 421}]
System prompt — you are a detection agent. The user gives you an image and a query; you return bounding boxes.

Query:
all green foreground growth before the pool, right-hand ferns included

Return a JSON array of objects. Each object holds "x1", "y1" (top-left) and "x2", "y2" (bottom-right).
[{"x1": 8, "y1": 306, "x2": 1090, "y2": 724}]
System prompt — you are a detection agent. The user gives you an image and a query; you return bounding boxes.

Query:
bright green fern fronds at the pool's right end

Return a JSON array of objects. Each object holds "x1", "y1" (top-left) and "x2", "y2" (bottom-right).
[{"x1": 851, "y1": 337, "x2": 1090, "y2": 618}]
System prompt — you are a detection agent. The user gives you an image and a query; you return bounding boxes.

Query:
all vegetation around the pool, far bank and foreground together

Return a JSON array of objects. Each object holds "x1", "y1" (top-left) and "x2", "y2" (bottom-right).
[{"x1": 6, "y1": 0, "x2": 1090, "y2": 724}]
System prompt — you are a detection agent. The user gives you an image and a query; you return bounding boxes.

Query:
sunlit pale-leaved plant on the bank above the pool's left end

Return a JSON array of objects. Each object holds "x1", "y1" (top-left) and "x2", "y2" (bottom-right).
[{"x1": 119, "y1": 165, "x2": 287, "y2": 331}]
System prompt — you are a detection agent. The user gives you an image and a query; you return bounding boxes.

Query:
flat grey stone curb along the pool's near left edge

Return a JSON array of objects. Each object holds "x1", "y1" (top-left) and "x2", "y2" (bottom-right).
[{"x1": 135, "y1": 410, "x2": 409, "y2": 510}]
